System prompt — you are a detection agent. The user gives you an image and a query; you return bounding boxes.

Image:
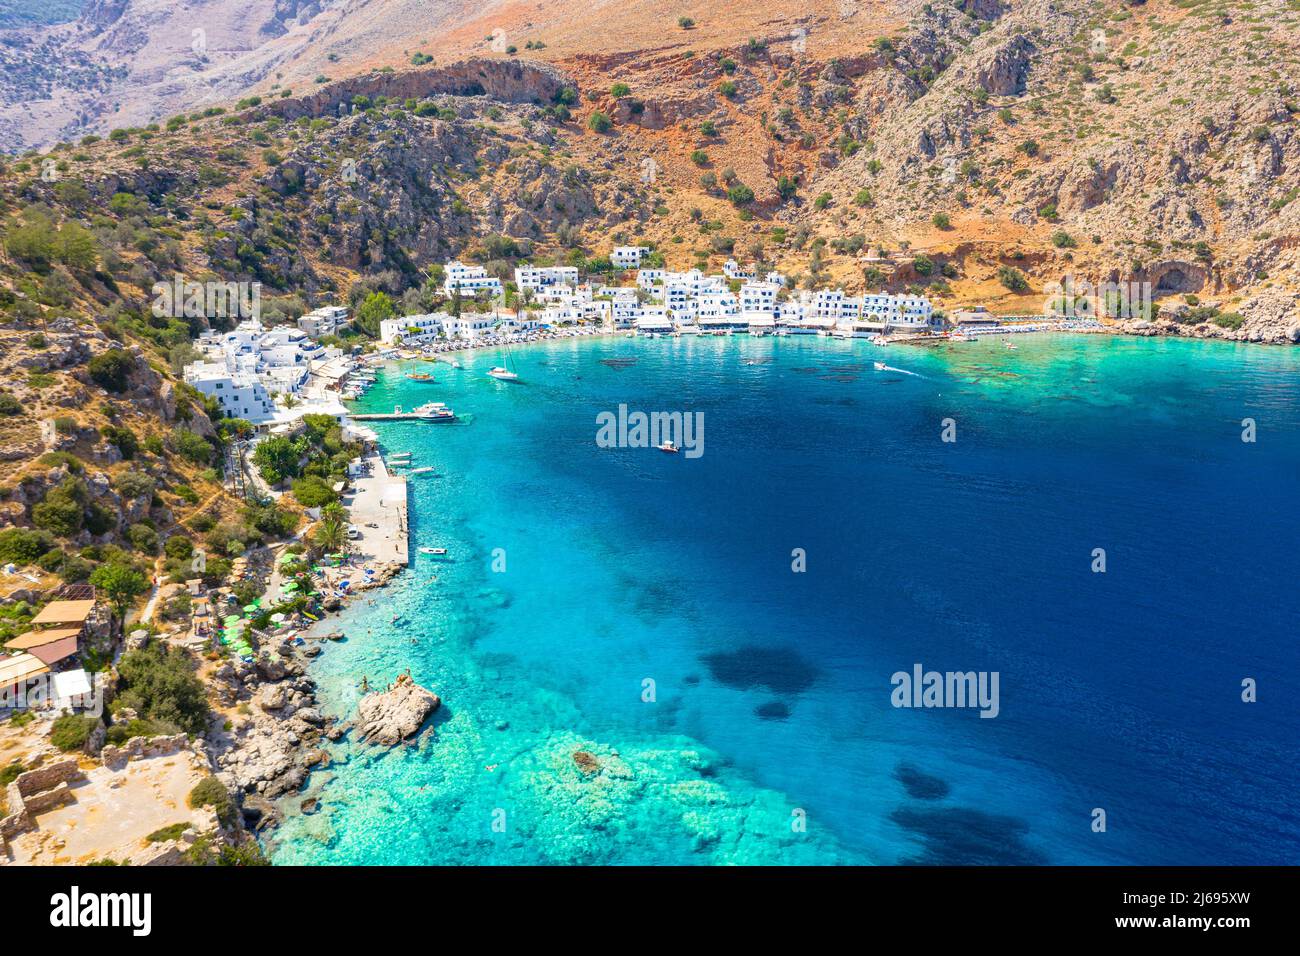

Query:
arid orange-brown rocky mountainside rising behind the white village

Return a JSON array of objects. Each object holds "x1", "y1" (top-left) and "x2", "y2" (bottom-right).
[{"x1": 0, "y1": 0, "x2": 1300, "y2": 341}]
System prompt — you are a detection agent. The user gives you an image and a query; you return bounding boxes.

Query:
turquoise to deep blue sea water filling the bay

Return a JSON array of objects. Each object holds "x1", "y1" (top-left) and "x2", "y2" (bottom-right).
[{"x1": 269, "y1": 336, "x2": 1300, "y2": 864}]
